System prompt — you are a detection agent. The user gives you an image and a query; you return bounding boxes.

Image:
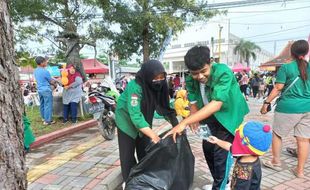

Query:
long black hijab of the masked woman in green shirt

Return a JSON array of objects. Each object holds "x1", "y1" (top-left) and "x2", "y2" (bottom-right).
[{"x1": 136, "y1": 60, "x2": 178, "y2": 126}]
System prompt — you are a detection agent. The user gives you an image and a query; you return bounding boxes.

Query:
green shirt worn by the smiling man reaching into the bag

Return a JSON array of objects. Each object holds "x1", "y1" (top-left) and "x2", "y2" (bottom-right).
[{"x1": 186, "y1": 64, "x2": 249, "y2": 135}]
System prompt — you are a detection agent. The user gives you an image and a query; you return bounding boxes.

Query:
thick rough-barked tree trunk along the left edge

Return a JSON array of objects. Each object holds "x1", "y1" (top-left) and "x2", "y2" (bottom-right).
[{"x1": 0, "y1": 0, "x2": 27, "y2": 190}]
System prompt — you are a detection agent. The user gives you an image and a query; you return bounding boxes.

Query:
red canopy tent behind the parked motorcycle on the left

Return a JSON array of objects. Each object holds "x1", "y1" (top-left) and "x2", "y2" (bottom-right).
[{"x1": 81, "y1": 59, "x2": 109, "y2": 74}]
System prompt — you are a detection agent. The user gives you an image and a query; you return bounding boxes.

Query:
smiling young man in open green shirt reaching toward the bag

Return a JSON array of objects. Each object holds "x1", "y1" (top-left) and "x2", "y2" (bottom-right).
[{"x1": 165, "y1": 46, "x2": 249, "y2": 190}]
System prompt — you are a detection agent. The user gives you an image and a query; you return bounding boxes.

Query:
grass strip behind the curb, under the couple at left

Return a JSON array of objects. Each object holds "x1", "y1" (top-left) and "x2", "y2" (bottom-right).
[{"x1": 26, "y1": 106, "x2": 92, "y2": 137}]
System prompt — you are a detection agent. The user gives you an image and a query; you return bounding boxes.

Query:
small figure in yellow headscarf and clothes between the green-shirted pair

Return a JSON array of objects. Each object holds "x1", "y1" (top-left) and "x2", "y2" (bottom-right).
[{"x1": 174, "y1": 90, "x2": 190, "y2": 118}]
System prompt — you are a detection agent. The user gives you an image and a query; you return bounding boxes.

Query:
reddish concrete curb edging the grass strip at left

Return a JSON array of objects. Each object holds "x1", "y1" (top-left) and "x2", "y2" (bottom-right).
[{"x1": 30, "y1": 119, "x2": 97, "y2": 148}]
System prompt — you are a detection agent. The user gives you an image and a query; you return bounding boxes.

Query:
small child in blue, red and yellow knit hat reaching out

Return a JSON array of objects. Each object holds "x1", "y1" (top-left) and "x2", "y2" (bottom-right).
[{"x1": 208, "y1": 121, "x2": 272, "y2": 190}]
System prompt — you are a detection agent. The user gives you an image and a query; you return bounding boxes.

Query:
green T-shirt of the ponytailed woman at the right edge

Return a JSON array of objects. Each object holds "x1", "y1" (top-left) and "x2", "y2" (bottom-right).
[{"x1": 276, "y1": 61, "x2": 310, "y2": 113}]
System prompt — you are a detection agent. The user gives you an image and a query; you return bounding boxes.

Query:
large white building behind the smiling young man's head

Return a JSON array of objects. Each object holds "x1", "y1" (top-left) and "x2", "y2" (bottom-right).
[{"x1": 163, "y1": 20, "x2": 273, "y2": 73}]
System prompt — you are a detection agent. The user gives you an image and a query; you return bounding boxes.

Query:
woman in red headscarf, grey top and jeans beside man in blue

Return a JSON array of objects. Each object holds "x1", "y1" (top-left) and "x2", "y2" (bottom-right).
[{"x1": 62, "y1": 64, "x2": 83, "y2": 124}]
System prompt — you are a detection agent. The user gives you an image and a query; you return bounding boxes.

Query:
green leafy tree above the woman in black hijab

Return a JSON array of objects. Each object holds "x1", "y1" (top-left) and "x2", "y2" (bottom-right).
[{"x1": 97, "y1": 0, "x2": 219, "y2": 62}]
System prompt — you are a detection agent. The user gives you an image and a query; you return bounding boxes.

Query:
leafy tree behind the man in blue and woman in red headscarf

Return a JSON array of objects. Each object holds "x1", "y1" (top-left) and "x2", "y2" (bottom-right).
[{"x1": 10, "y1": 0, "x2": 109, "y2": 79}]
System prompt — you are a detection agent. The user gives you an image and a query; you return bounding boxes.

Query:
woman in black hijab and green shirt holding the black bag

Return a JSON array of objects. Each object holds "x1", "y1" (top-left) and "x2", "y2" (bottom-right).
[{"x1": 115, "y1": 60, "x2": 178, "y2": 184}]
